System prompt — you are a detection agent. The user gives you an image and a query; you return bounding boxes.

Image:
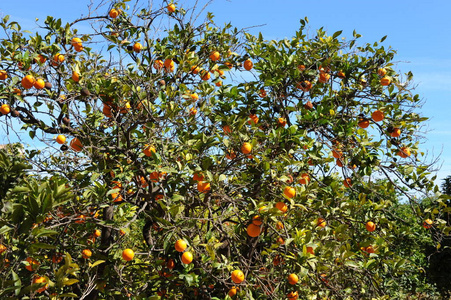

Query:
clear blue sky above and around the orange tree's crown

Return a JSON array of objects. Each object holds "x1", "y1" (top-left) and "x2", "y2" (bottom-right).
[{"x1": 0, "y1": 0, "x2": 451, "y2": 184}]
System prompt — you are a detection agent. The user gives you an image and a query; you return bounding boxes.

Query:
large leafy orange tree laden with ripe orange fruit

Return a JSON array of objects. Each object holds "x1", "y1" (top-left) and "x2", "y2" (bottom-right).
[{"x1": 0, "y1": 1, "x2": 450, "y2": 299}]
